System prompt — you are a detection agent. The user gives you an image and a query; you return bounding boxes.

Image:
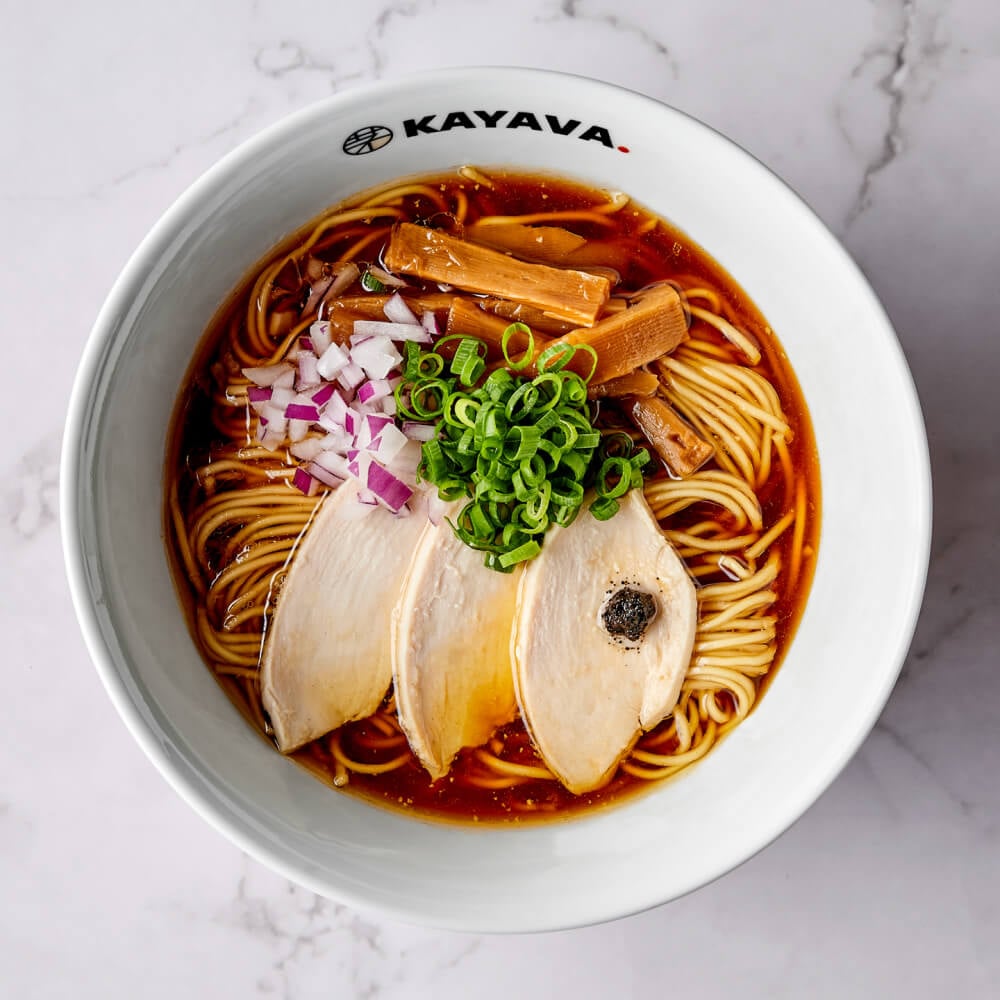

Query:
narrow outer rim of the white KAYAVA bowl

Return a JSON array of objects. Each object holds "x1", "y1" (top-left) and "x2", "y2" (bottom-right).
[{"x1": 59, "y1": 66, "x2": 932, "y2": 932}]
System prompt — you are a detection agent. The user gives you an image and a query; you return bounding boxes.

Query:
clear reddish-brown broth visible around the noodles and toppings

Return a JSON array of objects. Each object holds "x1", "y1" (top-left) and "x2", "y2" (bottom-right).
[{"x1": 167, "y1": 171, "x2": 820, "y2": 822}]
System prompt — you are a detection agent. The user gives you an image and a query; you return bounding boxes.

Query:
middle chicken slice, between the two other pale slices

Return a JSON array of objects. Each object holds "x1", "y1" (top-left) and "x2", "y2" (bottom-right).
[{"x1": 392, "y1": 504, "x2": 521, "y2": 780}]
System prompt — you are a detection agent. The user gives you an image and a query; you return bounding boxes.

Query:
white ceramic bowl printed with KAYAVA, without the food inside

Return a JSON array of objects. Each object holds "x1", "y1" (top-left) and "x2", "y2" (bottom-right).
[{"x1": 62, "y1": 69, "x2": 930, "y2": 931}]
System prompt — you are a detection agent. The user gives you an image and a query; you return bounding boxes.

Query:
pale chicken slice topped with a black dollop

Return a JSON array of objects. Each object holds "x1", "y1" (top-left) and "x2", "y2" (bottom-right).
[{"x1": 511, "y1": 490, "x2": 697, "y2": 794}]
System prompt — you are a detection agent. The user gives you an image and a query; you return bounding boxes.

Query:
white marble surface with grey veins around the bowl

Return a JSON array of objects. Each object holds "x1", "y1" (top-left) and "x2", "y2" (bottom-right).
[{"x1": 0, "y1": 0, "x2": 1000, "y2": 1000}]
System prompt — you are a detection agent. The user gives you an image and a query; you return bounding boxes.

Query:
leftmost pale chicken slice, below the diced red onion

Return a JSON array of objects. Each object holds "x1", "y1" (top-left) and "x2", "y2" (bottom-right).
[{"x1": 261, "y1": 482, "x2": 427, "y2": 753}]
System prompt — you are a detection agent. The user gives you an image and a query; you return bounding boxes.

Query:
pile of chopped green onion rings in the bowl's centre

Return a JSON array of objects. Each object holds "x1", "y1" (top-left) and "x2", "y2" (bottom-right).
[{"x1": 394, "y1": 323, "x2": 650, "y2": 573}]
